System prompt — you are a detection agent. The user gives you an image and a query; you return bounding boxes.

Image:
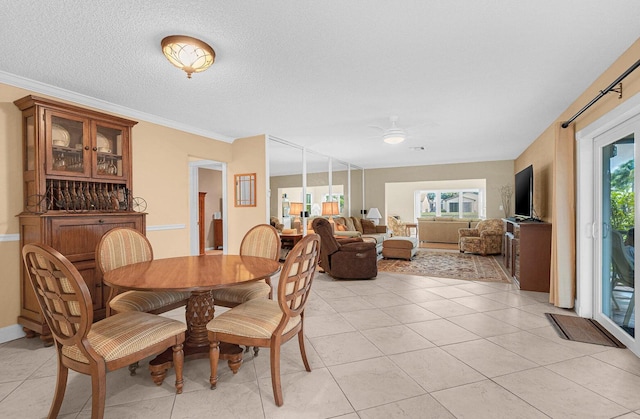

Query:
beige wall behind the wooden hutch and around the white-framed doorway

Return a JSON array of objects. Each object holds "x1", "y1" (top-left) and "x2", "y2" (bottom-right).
[{"x1": 0, "y1": 84, "x2": 266, "y2": 334}]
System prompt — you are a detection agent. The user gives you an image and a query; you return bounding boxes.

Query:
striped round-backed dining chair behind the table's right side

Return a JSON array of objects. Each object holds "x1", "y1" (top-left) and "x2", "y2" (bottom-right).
[{"x1": 211, "y1": 224, "x2": 280, "y2": 307}]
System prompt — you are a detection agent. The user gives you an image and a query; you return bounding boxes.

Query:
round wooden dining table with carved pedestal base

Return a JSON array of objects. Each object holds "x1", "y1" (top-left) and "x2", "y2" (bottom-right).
[{"x1": 103, "y1": 255, "x2": 280, "y2": 384}]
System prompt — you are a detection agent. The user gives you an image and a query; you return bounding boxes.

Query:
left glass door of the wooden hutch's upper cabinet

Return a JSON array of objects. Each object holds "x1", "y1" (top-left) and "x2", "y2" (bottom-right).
[{"x1": 44, "y1": 111, "x2": 91, "y2": 177}]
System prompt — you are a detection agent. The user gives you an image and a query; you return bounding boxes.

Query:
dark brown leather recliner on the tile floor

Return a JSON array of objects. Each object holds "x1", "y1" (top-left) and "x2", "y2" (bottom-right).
[{"x1": 312, "y1": 218, "x2": 378, "y2": 279}]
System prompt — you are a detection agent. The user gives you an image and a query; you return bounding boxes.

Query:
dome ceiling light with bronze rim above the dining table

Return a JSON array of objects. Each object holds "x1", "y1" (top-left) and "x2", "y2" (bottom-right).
[{"x1": 160, "y1": 35, "x2": 216, "y2": 78}]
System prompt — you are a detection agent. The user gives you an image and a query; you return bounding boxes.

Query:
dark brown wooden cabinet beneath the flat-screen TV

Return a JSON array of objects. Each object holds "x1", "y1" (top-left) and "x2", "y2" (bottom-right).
[{"x1": 502, "y1": 219, "x2": 551, "y2": 292}]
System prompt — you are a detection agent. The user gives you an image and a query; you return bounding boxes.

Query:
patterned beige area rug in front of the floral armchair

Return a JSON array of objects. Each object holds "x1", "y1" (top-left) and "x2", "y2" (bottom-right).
[{"x1": 378, "y1": 249, "x2": 510, "y2": 282}]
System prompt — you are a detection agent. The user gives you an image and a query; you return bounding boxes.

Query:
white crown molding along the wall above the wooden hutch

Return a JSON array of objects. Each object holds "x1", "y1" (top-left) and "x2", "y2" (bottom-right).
[{"x1": 0, "y1": 71, "x2": 235, "y2": 143}]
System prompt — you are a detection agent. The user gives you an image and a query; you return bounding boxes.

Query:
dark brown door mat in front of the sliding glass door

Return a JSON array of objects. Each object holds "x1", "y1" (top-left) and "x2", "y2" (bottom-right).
[{"x1": 545, "y1": 313, "x2": 626, "y2": 348}]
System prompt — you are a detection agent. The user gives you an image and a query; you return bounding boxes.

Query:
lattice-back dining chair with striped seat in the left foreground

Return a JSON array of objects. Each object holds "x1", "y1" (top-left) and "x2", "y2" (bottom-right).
[{"x1": 22, "y1": 243, "x2": 187, "y2": 419}]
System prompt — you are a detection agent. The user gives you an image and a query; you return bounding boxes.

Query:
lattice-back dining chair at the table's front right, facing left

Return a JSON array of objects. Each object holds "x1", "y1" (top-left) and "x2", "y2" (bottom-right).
[{"x1": 207, "y1": 234, "x2": 320, "y2": 406}]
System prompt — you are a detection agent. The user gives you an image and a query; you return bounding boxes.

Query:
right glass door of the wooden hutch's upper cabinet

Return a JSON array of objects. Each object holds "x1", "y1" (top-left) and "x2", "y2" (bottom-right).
[{"x1": 91, "y1": 123, "x2": 129, "y2": 178}]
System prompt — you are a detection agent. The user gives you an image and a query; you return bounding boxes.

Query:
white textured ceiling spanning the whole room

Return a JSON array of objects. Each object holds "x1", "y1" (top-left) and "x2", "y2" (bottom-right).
[{"x1": 0, "y1": 0, "x2": 640, "y2": 173}]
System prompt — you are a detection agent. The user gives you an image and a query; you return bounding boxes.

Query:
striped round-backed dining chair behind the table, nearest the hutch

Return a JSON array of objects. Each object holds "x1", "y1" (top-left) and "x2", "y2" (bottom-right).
[{"x1": 96, "y1": 227, "x2": 190, "y2": 316}]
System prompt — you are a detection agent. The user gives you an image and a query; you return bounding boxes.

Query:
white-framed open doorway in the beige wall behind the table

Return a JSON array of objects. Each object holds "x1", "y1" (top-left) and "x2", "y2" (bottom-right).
[{"x1": 189, "y1": 160, "x2": 227, "y2": 255}]
